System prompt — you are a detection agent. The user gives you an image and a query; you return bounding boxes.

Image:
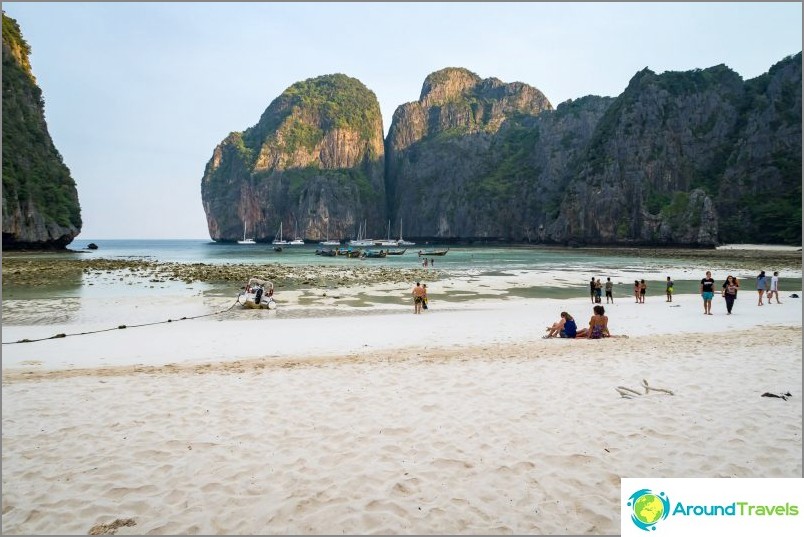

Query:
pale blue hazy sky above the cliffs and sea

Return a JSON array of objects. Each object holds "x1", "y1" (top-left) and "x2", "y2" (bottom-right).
[{"x1": 2, "y1": 2, "x2": 802, "y2": 241}]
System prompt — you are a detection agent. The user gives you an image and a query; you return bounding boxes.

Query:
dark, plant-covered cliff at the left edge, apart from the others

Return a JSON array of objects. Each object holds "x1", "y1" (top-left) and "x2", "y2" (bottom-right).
[{"x1": 3, "y1": 14, "x2": 81, "y2": 250}]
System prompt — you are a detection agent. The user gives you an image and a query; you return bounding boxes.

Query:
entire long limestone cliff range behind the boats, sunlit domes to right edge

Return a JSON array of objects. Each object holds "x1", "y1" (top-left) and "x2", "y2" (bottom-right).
[{"x1": 203, "y1": 53, "x2": 801, "y2": 247}]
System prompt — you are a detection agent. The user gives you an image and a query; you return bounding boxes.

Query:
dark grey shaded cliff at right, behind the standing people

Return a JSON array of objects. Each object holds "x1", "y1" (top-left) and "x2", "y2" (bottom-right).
[{"x1": 548, "y1": 54, "x2": 801, "y2": 246}]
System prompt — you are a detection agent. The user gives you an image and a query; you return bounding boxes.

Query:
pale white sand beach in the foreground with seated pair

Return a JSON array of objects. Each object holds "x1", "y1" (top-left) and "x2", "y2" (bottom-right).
[{"x1": 2, "y1": 288, "x2": 802, "y2": 534}]
